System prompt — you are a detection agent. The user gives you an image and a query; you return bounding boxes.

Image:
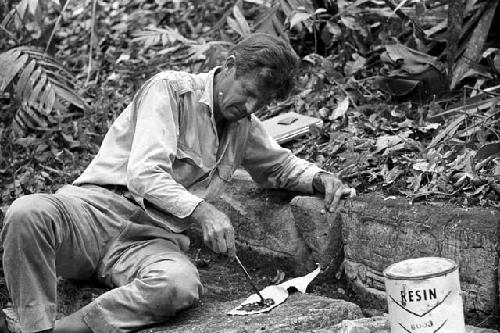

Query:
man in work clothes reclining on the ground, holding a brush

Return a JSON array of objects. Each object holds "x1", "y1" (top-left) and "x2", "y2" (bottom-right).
[{"x1": 0, "y1": 34, "x2": 351, "y2": 333}]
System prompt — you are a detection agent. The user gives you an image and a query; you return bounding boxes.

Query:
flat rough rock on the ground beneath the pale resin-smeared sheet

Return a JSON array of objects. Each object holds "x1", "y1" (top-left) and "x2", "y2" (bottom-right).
[{"x1": 142, "y1": 293, "x2": 362, "y2": 333}]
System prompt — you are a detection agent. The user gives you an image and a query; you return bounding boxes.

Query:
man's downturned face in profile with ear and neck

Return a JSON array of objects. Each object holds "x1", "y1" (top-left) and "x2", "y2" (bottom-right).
[{"x1": 217, "y1": 67, "x2": 275, "y2": 122}]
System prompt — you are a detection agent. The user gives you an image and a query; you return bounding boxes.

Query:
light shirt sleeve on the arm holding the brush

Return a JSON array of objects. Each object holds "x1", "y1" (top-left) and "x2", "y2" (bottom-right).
[{"x1": 127, "y1": 79, "x2": 203, "y2": 218}]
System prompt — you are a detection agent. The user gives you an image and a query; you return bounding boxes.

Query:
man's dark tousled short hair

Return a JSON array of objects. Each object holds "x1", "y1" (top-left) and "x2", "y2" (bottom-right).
[{"x1": 230, "y1": 33, "x2": 299, "y2": 99}]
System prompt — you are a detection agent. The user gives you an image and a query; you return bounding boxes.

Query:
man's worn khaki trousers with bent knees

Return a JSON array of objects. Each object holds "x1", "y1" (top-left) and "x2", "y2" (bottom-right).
[{"x1": 1, "y1": 185, "x2": 202, "y2": 333}]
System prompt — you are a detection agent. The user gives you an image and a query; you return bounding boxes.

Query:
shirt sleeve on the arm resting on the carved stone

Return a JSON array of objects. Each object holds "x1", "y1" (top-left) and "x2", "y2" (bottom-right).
[{"x1": 242, "y1": 116, "x2": 322, "y2": 193}]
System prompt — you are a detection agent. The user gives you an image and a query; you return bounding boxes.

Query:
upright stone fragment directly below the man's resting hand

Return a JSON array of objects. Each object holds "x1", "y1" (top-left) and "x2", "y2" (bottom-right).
[{"x1": 290, "y1": 196, "x2": 344, "y2": 274}]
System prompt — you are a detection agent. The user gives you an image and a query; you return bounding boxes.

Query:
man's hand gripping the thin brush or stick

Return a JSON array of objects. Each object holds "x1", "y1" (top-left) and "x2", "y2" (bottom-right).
[{"x1": 190, "y1": 201, "x2": 236, "y2": 258}]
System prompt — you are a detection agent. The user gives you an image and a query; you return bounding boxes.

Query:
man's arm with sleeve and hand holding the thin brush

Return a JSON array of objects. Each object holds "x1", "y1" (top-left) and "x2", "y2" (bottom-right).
[{"x1": 127, "y1": 80, "x2": 235, "y2": 256}]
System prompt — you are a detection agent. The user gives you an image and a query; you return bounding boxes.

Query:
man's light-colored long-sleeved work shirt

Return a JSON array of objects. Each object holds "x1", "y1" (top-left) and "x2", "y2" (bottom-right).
[{"x1": 73, "y1": 68, "x2": 321, "y2": 232}]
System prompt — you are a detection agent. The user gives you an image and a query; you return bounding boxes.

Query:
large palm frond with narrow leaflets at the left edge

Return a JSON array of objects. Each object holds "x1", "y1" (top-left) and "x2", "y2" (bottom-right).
[{"x1": 0, "y1": 47, "x2": 87, "y2": 128}]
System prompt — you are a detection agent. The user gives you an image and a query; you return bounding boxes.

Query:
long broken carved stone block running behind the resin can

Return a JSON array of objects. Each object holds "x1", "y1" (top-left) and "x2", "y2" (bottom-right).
[{"x1": 210, "y1": 172, "x2": 499, "y2": 317}]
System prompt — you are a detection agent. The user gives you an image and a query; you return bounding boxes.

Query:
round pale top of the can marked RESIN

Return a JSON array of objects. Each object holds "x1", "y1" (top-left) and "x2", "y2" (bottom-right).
[{"x1": 384, "y1": 257, "x2": 458, "y2": 280}]
